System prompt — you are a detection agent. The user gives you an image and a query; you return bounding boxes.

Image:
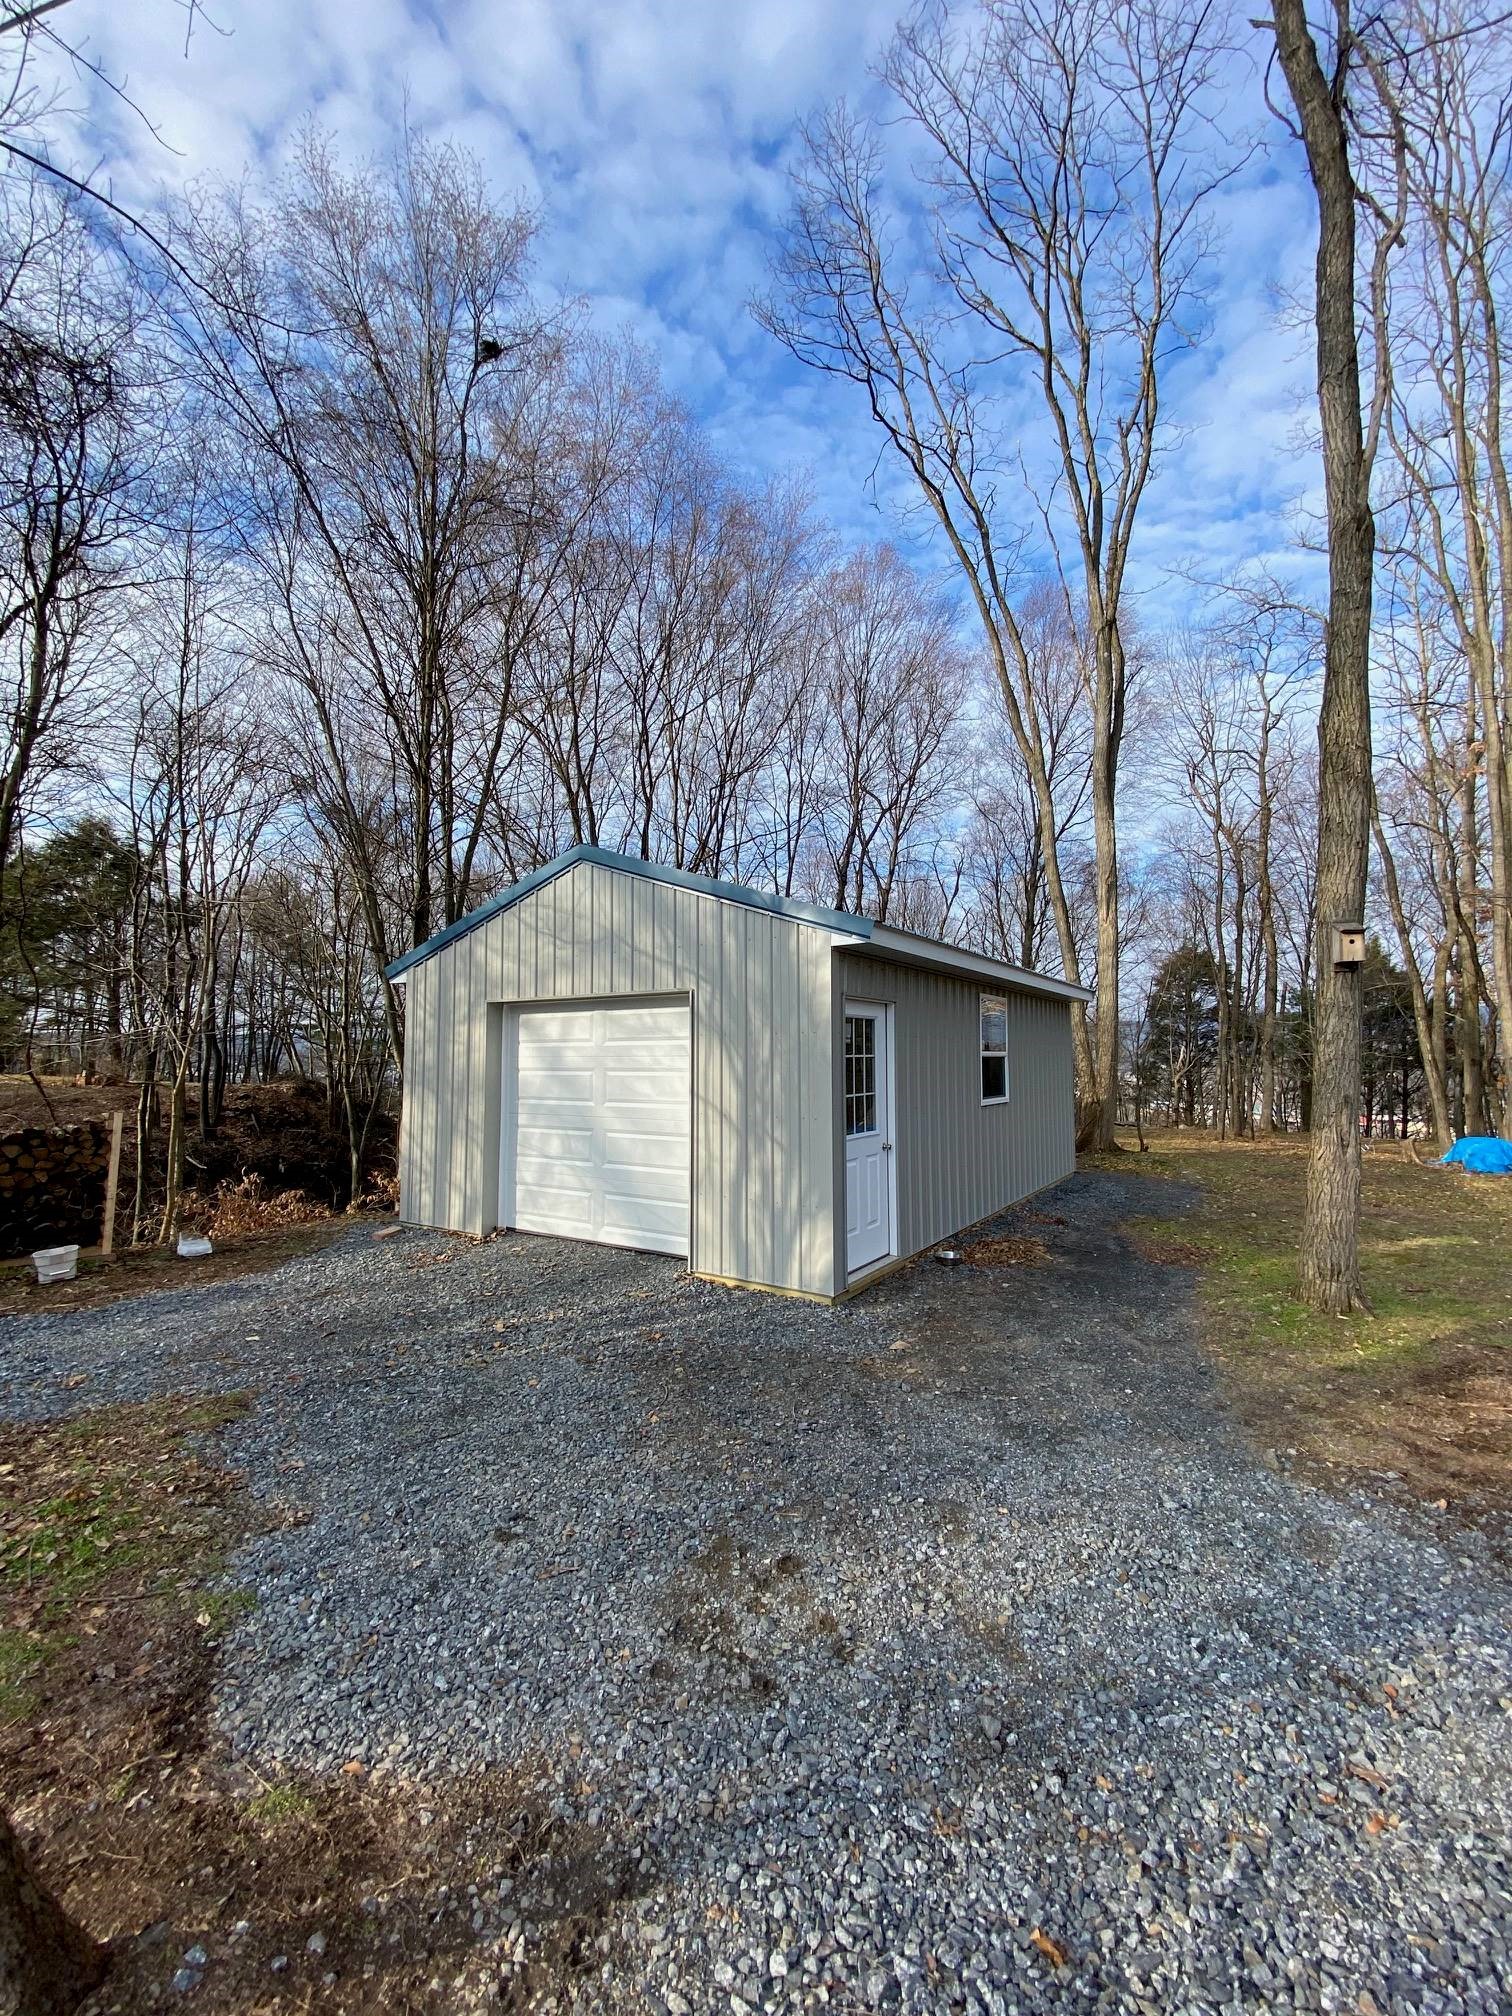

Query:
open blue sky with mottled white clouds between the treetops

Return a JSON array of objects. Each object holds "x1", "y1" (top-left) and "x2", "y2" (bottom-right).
[{"x1": 41, "y1": 0, "x2": 1316, "y2": 623}]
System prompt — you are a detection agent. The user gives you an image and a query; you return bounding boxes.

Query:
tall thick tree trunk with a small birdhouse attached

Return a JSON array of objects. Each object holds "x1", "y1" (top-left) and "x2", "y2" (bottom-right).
[{"x1": 1274, "y1": 0, "x2": 1375, "y2": 1314}]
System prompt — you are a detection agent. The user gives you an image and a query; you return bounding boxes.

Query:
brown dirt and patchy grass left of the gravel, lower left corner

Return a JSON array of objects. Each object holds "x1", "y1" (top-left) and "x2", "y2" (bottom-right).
[{"x1": 0, "y1": 1395, "x2": 649, "y2": 2016}]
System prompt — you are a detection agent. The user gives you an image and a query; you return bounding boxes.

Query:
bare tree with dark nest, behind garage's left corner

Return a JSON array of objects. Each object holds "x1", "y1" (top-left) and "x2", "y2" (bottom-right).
[{"x1": 179, "y1": 133, "x2": 560, "y2": 1060}]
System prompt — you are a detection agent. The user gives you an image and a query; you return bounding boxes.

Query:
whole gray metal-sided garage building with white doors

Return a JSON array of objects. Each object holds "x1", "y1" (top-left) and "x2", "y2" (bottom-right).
[{"x1": 389, "y1": 847, "x2": 1089, "y2": 1298}]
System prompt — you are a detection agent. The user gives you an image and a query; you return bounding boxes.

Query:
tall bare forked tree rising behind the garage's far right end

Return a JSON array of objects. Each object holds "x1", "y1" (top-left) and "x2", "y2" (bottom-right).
[{"x1": 760, "y1": 0, "x2": 1232, "y2": 1145}]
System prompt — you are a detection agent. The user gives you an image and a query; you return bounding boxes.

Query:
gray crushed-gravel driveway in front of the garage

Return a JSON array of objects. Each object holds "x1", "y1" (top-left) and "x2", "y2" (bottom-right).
[{"x1": 0, "y1": 1175, "x2": 1512, "y2": 2016}]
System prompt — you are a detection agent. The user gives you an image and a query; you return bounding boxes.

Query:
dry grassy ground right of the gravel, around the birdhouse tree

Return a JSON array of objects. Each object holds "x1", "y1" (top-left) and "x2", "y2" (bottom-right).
[{"x1": 1119, "y1": 1131, "x2": 1512, "y2": 1512}]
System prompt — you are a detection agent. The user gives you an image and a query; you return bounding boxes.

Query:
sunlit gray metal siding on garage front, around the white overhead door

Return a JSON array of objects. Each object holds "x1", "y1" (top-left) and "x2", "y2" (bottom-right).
[{"x1": 399, "y1": 863, "x2": 843, "y2": 1294}]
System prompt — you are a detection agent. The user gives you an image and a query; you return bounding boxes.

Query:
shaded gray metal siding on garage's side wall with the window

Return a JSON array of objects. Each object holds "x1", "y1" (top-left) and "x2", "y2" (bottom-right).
[{"x1": 835, "y1": 954, "x2": 1077, "y2": 1278}]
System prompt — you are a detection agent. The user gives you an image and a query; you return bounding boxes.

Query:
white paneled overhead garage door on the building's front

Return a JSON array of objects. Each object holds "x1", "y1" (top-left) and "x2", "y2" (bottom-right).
[{"x1": 512, "y1": 1002, "x2": 691, "y2": 1254}]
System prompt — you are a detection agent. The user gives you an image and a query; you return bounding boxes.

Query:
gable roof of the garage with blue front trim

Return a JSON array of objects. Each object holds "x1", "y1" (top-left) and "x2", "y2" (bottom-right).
[{"x1": 385, "y1": 847, "x2": 1093, "y2": 1000}]
